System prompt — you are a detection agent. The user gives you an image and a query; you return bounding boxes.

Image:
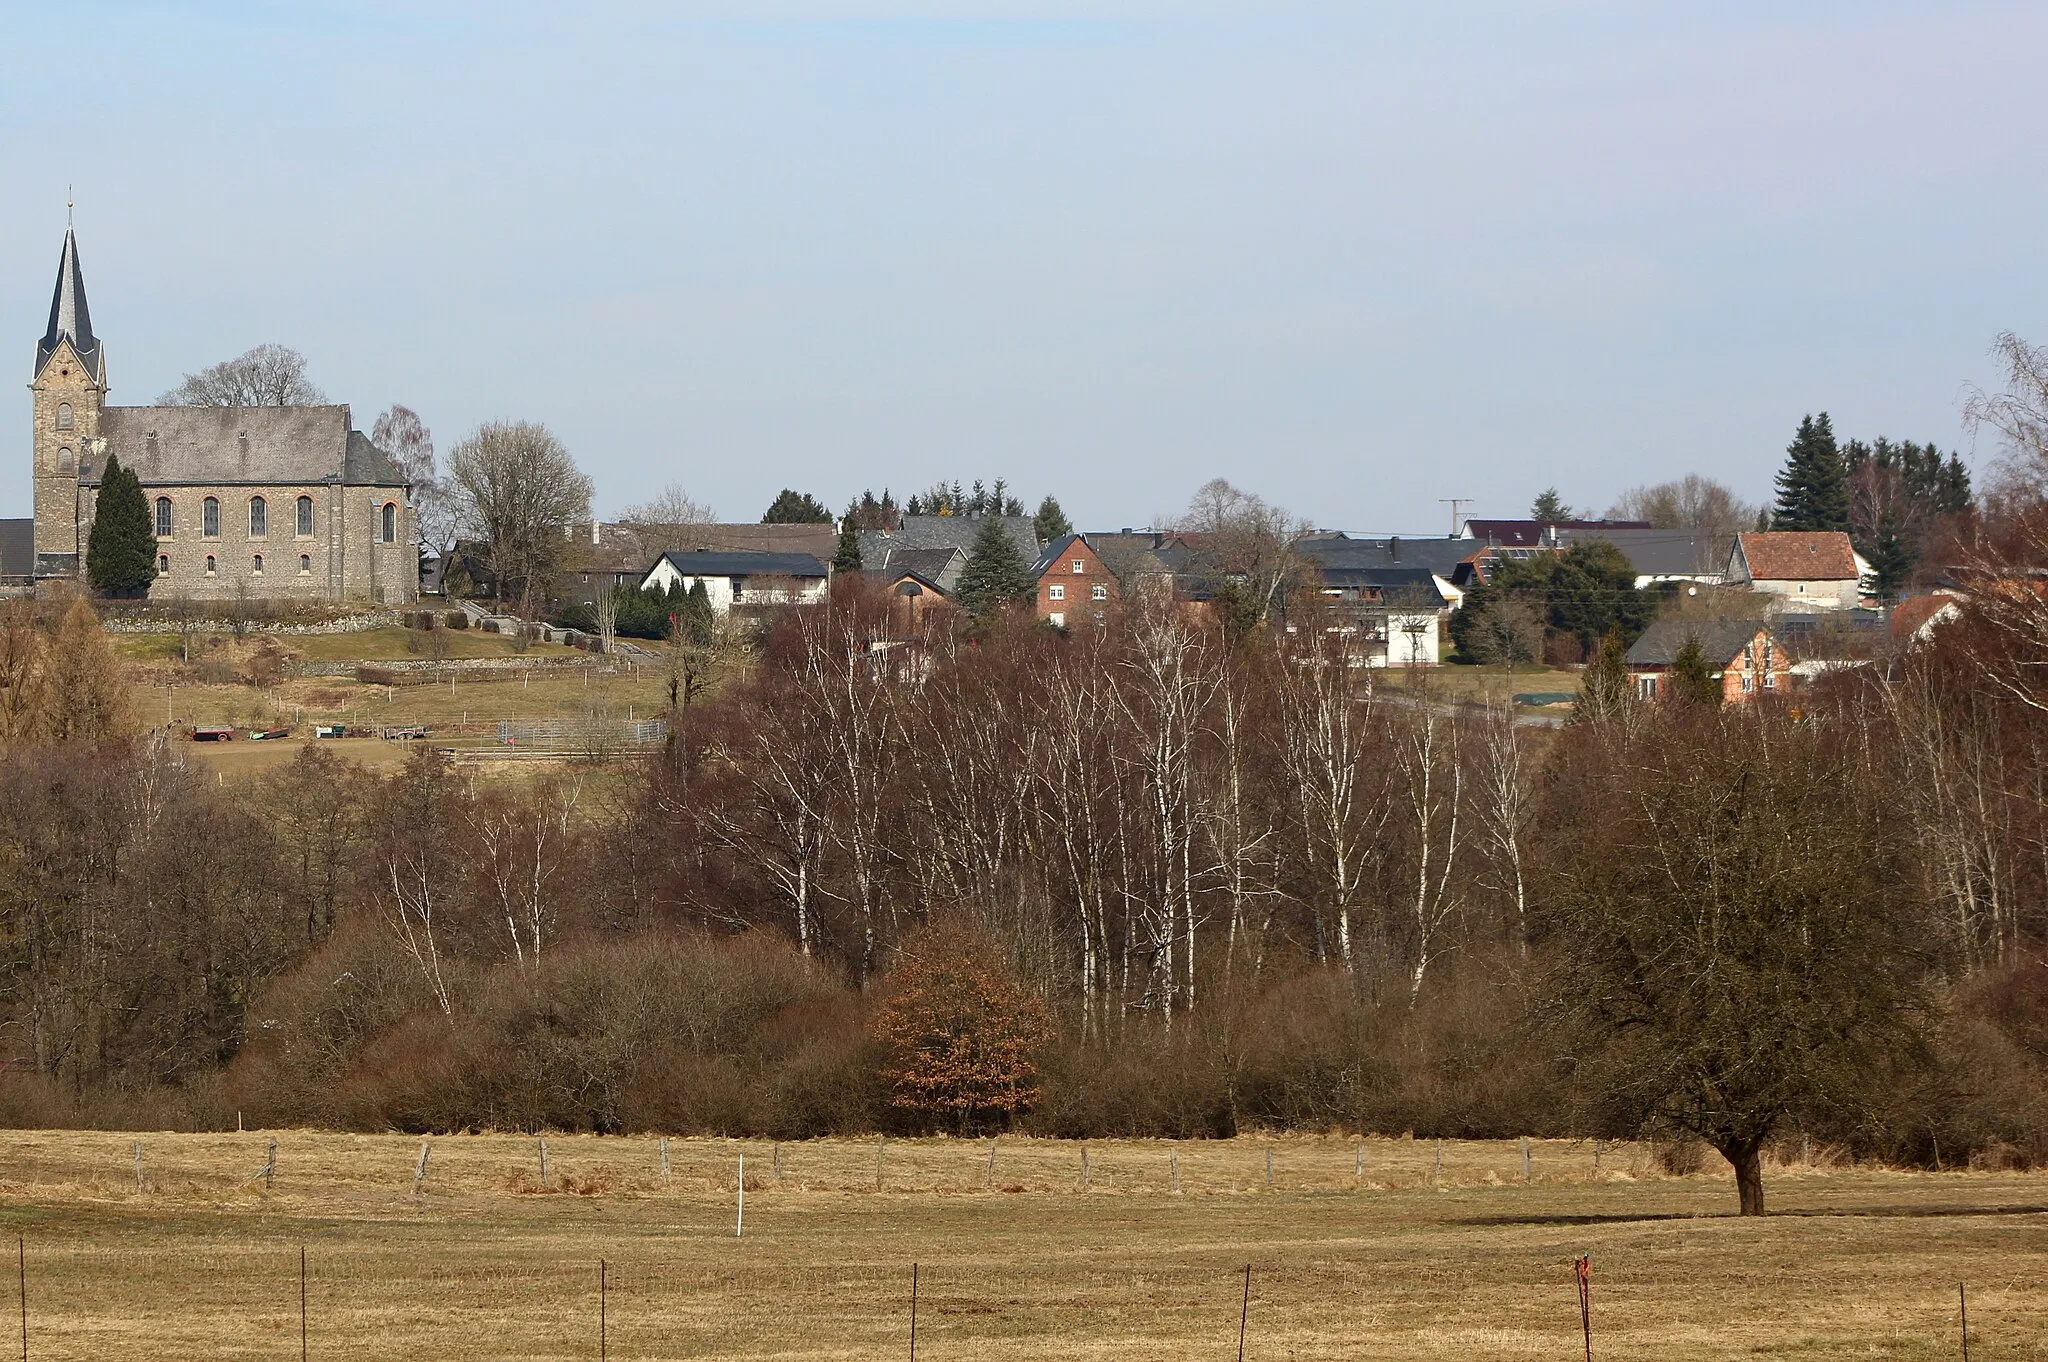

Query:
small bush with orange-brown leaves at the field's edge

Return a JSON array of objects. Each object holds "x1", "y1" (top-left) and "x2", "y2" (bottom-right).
[{"x1": 874, "y1": 930, "x2": 1053, "y2": 1135}]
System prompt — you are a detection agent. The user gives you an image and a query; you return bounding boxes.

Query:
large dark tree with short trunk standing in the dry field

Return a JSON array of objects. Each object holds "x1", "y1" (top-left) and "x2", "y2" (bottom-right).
[{"x1": 1534, "y1": 705, "x2": 1937, "y2": 1215}]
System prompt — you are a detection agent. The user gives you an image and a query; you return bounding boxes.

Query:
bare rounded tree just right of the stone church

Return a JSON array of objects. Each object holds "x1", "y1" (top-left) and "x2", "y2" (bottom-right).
[{"x1": 449, "y1": 413, "x2": 592, "y2": 614}]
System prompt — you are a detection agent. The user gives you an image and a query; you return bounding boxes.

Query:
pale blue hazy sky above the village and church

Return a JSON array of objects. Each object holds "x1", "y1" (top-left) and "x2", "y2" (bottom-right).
[{"x1": 0, "y1": 0, "x2": 2048, "y2": 533}]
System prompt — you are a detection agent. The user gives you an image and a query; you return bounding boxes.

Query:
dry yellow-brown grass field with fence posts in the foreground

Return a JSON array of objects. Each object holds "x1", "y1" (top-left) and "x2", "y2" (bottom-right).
[{"x1": 0, "y1": 1131, "x2": 2048, "y2": 1362}]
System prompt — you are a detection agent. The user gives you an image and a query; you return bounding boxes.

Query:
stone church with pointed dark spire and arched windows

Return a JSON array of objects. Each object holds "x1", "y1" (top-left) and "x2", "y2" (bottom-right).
[{"x1": 27, "y1": 227, "x2": 420, "y2": 604}]
